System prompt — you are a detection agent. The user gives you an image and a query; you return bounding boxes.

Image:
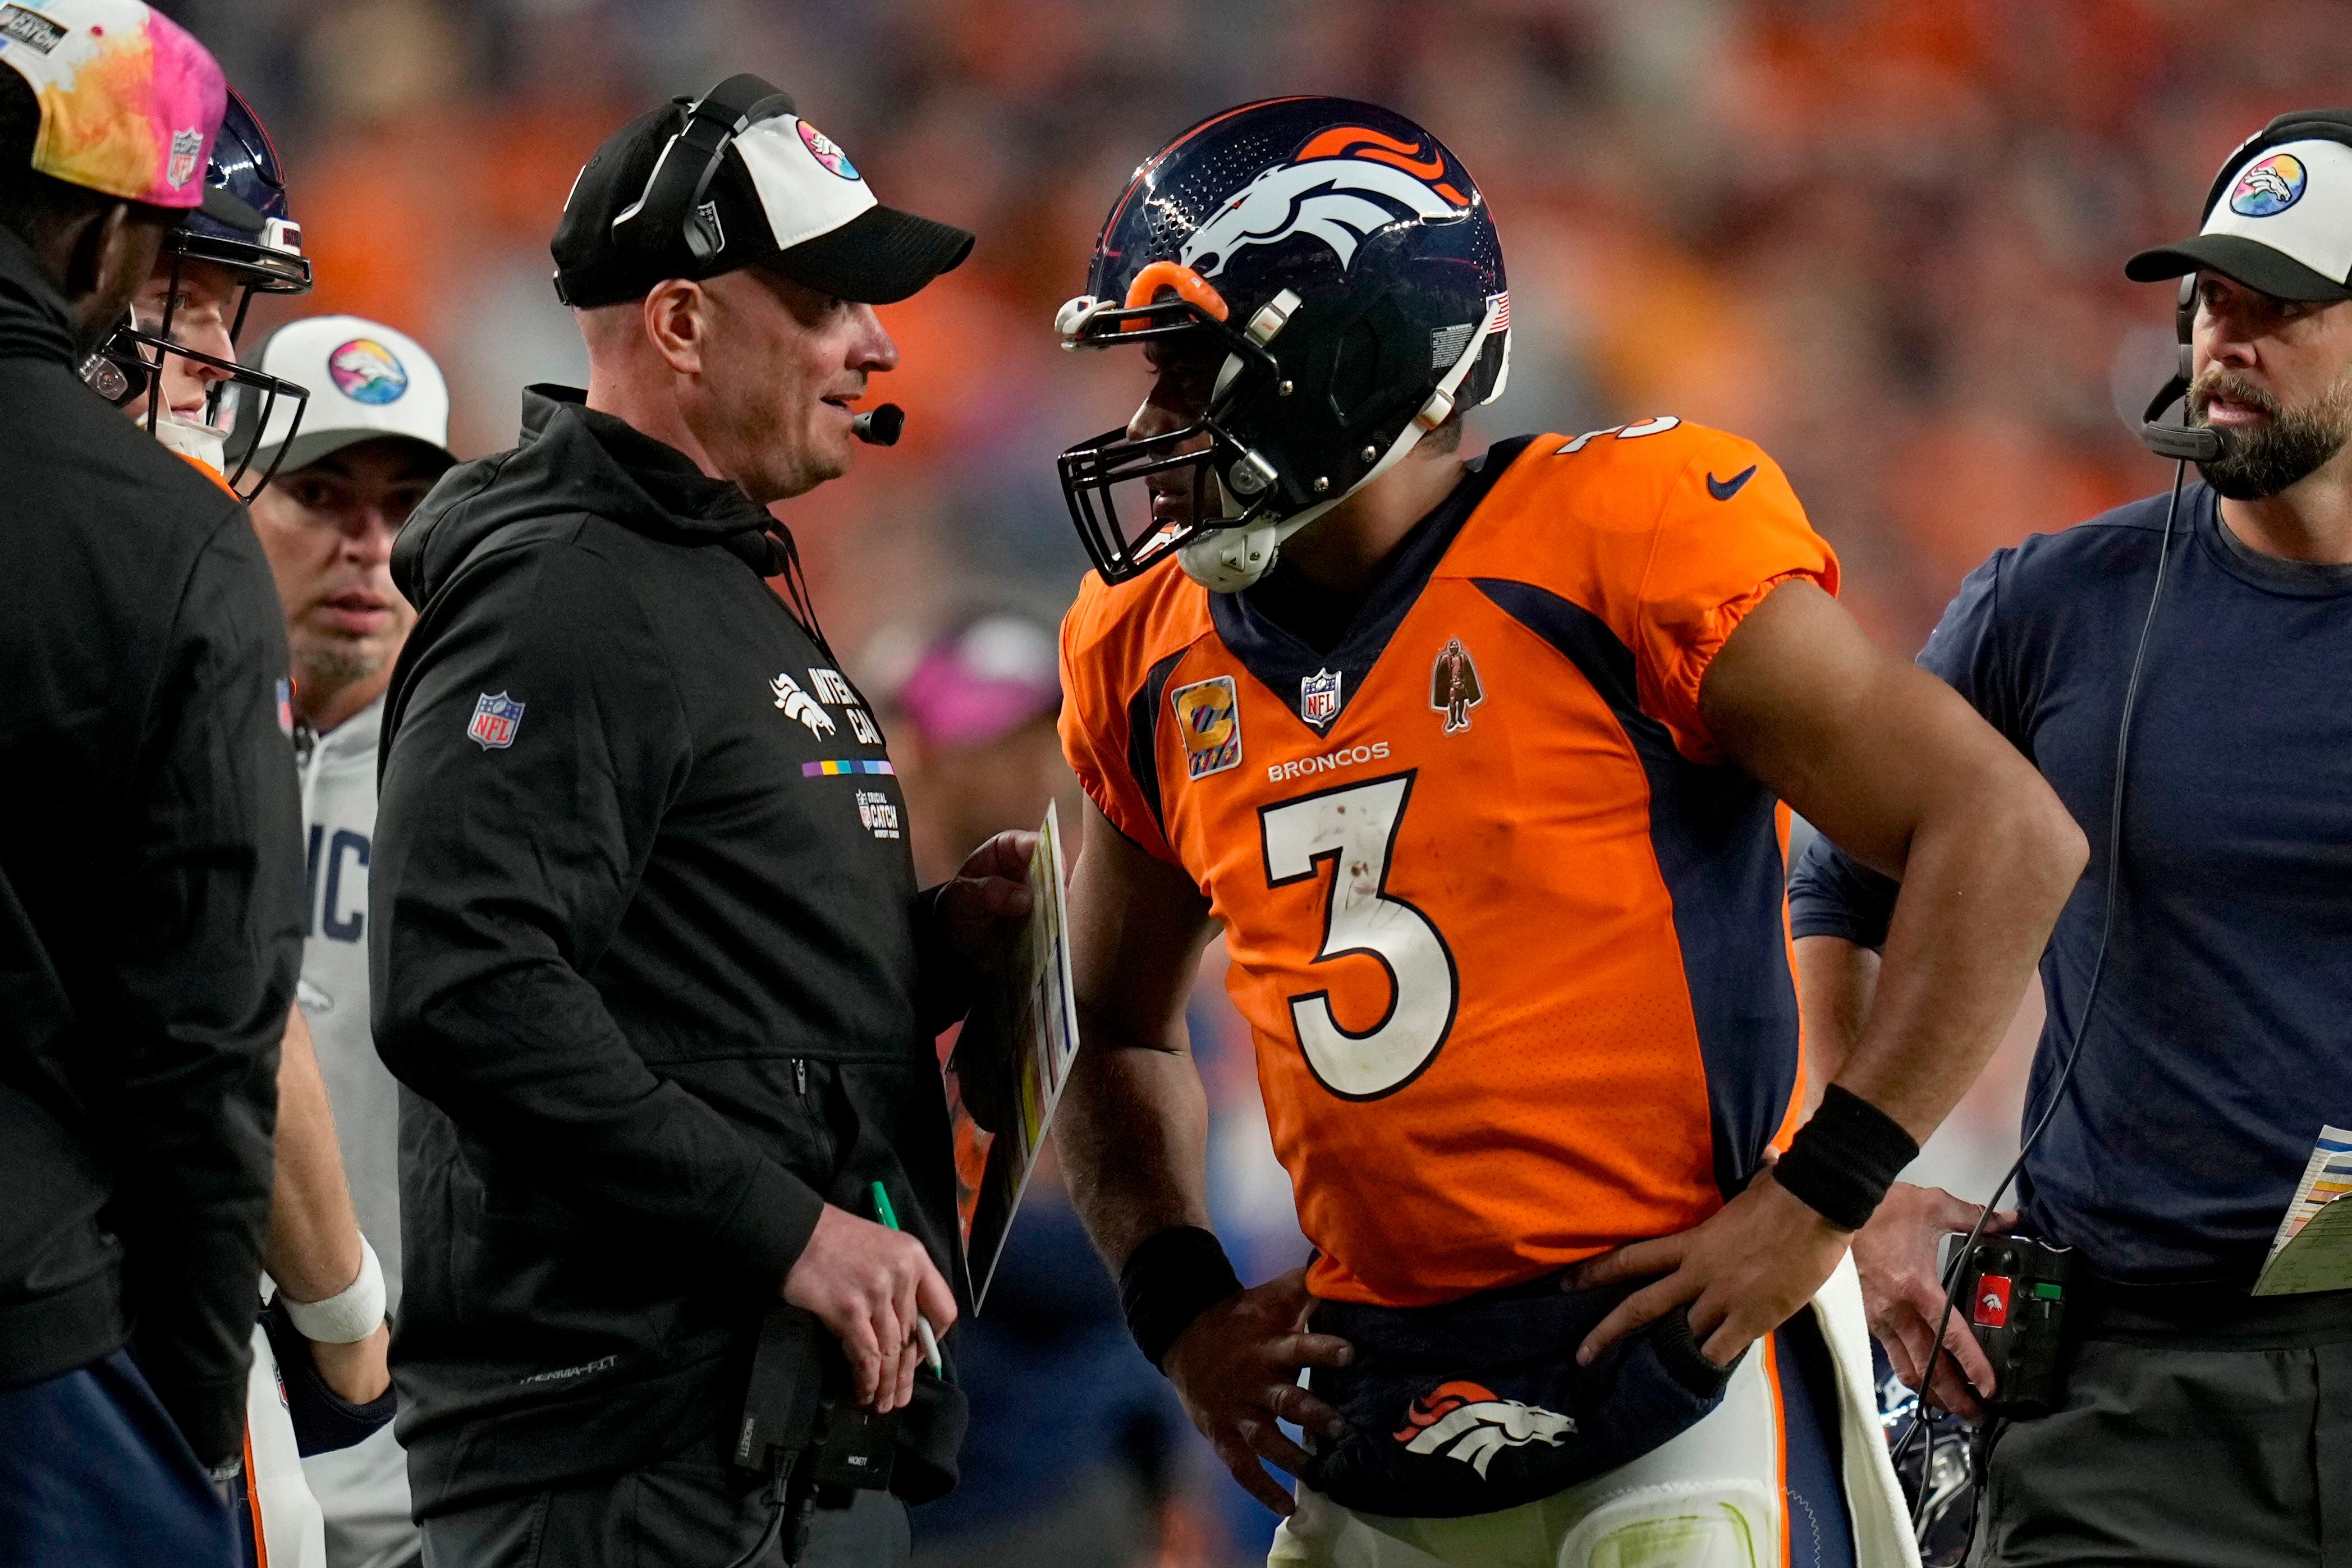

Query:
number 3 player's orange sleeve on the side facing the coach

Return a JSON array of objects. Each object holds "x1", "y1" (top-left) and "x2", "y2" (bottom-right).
[{"x1": 1061, "y1": 571, "x2": 1176, "y2": 865}]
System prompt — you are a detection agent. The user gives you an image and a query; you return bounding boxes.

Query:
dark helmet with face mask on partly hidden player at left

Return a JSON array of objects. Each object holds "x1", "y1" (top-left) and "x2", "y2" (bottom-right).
[{"x1": 82, "y1": 89, "x2": 310, "y2": 501}]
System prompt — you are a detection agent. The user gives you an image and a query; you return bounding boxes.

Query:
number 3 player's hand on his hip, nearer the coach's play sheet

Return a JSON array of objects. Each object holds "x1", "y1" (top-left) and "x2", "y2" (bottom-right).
[{"x1": 1159, "y1": 1269, "x2": 1355, "y2": 1519}]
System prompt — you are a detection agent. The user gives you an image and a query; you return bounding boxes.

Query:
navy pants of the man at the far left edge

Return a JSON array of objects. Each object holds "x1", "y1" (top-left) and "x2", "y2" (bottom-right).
[{"x1": 0, "y1": 1349, "x2": 237, "y2": 1568}]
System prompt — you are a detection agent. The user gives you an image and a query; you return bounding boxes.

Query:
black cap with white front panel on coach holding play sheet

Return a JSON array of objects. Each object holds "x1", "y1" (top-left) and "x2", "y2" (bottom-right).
[{"x1": 548, "y1": 94, "x2": 971, "y2": 308}]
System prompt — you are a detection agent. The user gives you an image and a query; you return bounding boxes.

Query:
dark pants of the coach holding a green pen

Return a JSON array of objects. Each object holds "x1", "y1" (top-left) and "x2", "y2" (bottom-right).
[{"x1": 423, "y1": 1446, "x2": 910, "y2": 1568}]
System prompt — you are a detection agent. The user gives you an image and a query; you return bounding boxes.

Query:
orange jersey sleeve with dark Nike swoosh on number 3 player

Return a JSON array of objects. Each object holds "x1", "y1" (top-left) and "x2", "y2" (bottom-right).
[{"x1": 1635, "y1": 430, "x2": 1837, "y2": 764}]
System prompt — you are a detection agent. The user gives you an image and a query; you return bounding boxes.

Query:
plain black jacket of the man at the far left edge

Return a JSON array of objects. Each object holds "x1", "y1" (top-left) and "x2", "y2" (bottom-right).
[{"x1": 0, "y1": 231, "x2": 301, "y2": 1465}]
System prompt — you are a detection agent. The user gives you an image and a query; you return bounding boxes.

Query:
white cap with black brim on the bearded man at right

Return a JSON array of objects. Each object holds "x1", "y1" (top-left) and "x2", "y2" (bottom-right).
[{"x1": 2124, "y1": 108, "x2": 2352, "y2": 301}]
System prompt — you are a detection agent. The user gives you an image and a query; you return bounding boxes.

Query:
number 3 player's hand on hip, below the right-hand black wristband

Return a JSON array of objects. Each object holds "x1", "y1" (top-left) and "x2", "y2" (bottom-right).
[{"x1": 1562, "y1": 1168, "x2": 1854, "y2": 1366}]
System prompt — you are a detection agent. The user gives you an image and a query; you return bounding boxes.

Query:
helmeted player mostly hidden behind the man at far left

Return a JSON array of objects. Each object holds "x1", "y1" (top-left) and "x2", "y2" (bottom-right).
[{"x1": 106, "y1": 89, "x2": 393, "y2": 1568}]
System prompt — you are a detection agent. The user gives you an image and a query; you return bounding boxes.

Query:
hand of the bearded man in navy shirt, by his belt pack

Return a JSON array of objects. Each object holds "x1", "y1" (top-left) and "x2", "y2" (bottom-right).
[{"x1": 1854, "y1": 1182, "x2": 2018, "y2": 1420}]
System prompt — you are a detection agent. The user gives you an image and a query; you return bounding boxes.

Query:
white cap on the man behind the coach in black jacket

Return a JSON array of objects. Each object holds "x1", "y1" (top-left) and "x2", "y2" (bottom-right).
[{"x1": 254, "y1": 315, "x2": 456, "y2": 475}]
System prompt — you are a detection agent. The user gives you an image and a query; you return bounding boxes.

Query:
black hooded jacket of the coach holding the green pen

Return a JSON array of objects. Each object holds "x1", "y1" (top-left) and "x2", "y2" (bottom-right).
[{"x1": 369, "y1": 388, "x2": 960, "y2": 1514}]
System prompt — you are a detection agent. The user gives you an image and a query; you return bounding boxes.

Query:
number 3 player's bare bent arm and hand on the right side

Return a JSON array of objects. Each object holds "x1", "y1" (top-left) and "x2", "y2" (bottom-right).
[{"x1": 1583, "y1": 581, "x2": 2089, "y2": 1364}]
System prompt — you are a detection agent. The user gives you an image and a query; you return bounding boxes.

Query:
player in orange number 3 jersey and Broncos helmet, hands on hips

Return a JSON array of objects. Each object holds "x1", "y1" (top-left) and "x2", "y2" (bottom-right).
[{"x1": 1058, "y1": 99, "x2": 2084, "y2": 1568}]
